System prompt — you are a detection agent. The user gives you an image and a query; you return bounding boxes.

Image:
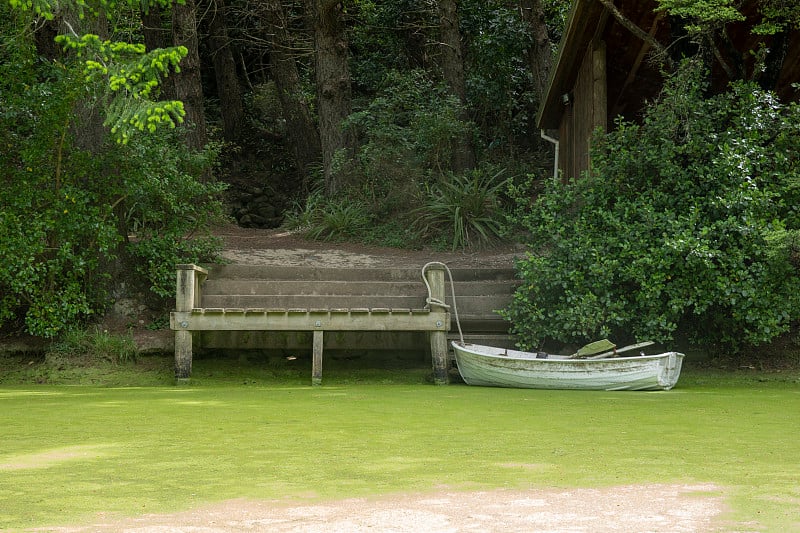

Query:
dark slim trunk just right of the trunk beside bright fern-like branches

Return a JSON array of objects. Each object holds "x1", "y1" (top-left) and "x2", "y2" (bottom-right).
[{"x1": 207, "y1": 0, "x2": 244, "y2": 142}]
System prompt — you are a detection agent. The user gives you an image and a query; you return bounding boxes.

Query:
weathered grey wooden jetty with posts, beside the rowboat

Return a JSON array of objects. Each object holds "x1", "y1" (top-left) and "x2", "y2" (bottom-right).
[{"x1": 170, "y1": 264, "x2": 450, "y2": 385}]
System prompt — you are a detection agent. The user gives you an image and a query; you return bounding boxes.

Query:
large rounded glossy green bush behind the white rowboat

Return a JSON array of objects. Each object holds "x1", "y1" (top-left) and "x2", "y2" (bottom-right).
[{"x1": 505, "y1": 65, "x2": 800, "y2": 351}]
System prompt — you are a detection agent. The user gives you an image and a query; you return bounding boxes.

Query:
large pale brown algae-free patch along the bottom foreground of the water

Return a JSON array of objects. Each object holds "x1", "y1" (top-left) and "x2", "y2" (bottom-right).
[{"x1": 47, "y1": 484, "x2": 725, "y2": 533}]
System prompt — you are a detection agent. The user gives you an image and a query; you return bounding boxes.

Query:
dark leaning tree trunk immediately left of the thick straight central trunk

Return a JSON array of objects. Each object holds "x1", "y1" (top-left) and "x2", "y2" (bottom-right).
[{"x1": 265, "y1": 0, "x2": 322, "y2": 182}]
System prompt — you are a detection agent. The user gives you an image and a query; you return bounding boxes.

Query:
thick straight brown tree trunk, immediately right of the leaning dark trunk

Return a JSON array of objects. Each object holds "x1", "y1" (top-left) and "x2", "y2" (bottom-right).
[{"x1": 306, "y1": 0, "x2": 353, "y2": 196}]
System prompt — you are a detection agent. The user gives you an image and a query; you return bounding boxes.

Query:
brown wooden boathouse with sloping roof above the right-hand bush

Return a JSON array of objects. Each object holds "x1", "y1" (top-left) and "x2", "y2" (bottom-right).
[{"x1": 538, "y1": 0, "x2": 800, "y2": 178}]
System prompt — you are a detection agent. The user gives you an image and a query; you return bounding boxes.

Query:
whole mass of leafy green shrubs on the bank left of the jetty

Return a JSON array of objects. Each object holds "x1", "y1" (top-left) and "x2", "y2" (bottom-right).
[{"x1": 0, "y1": 4, "x2": 225, "y2": 337}]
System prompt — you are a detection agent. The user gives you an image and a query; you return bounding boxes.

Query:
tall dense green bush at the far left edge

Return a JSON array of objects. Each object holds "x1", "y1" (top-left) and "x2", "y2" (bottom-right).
[{"x1": 0, "y1": 44, "x2": 120, "y2": 337}]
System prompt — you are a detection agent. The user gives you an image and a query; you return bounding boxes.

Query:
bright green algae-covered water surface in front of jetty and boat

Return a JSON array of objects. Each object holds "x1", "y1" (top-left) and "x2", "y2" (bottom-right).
[{"x1": 0, "y1": 357, "x2": 800, "y2": 531}]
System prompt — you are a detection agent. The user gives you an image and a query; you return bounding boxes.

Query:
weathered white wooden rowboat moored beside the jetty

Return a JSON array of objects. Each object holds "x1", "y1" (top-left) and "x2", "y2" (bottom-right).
[{"x1": 452, "y1": 341, "x2": 684, "y2": 390}]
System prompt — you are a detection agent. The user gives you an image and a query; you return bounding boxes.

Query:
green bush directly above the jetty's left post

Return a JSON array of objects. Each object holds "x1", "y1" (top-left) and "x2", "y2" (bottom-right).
[{"x1": 109, "y1": 127, "x2": 225, "y2": 298}]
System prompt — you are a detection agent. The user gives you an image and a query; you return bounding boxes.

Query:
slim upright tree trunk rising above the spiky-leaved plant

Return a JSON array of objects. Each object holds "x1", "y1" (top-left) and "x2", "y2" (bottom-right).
[{"x1": 437, "y1": 0, "x2": 475, "y2": 172}]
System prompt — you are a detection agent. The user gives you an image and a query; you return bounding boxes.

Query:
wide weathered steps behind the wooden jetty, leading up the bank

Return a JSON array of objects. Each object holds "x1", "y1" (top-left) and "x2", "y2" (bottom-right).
[{"x1": 195, "y1": 264, "x2": 518, "y2": 353}]
